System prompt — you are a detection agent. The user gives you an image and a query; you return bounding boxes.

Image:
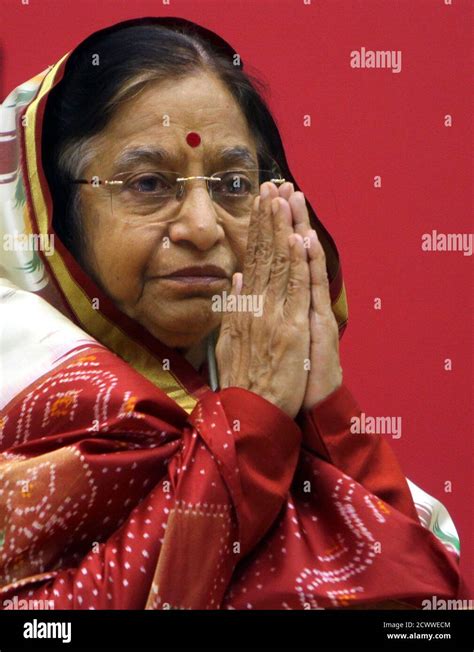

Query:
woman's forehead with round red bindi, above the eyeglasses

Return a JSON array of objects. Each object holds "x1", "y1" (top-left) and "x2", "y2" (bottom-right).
[{"x1": 95, "y1": 75, "x2": 257, "y2": 167}]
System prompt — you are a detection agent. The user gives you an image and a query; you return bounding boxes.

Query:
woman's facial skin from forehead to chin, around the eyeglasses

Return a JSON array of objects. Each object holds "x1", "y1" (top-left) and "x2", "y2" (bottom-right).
[{"x1": 81, "y1": 72, "x2": 257, "y2": 347}]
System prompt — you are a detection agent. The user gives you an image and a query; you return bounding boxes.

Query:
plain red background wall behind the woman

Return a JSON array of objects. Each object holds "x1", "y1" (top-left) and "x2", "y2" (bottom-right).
[{"x1": 0, "y1": 0, "x2": 473, "y2": 586}]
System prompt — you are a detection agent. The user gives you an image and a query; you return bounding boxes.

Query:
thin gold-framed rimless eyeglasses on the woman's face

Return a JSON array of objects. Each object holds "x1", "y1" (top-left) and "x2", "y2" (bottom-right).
[{"x1": 72, "y1": 164, "x2": 285, "y2": 221}]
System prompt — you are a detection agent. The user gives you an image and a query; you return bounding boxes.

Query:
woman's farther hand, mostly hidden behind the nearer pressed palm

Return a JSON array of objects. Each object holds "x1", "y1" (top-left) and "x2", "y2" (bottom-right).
[{"x1": 279, "y1": 183, "x2": 342, "y2": 409}]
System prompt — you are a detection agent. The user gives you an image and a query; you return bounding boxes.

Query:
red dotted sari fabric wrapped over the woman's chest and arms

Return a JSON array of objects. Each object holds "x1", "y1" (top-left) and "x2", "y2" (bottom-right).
[{"x1": 0, "y1": 344, "x2": 459, "y2": 609}]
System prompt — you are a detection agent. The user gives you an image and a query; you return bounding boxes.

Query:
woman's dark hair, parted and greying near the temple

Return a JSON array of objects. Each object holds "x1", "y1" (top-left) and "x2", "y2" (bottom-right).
[{"x1": 42, "y1": 18, "x2": 332, "y2": 272}]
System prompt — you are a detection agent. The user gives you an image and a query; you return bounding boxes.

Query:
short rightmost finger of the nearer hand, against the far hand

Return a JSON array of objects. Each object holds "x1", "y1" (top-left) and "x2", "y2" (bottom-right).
[{"x1": 284, "y1": 233, "x2": 310, "y2": 325}]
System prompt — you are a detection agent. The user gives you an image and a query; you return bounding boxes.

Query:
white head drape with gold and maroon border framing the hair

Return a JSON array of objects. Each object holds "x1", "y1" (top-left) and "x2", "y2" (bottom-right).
[{"x1": 0, "y1": 18, "x2": 347, "y2": 411}]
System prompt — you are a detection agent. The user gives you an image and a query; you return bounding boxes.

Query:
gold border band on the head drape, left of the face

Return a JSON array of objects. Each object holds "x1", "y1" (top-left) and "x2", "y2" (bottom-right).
[{"x1": 21, "y1": 54, "x2": 197, "y2": 414}]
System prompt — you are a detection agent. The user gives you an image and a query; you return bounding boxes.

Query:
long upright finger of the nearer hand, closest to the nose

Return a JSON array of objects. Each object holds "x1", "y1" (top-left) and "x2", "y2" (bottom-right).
[{"x1": 242, "y1": 182, "x2": 278, "y2": 294}]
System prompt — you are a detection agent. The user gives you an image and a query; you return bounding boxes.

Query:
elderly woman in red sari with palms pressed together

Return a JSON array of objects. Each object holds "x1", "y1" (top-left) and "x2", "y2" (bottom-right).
[{"x1": 0, "y1": 19, "x2": 459, "y2": 609}]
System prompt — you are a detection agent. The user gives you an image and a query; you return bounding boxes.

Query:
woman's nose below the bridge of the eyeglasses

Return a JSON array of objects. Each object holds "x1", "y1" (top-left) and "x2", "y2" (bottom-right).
[{"x1": 169, "y1": 185, "x2": 224, "y2": 251}]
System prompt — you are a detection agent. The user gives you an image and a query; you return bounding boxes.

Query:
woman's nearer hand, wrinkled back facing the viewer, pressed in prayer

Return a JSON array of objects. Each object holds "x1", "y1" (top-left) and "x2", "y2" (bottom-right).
[{"x1": 216, "y1": 182, "x2": 317, "y2": 418}]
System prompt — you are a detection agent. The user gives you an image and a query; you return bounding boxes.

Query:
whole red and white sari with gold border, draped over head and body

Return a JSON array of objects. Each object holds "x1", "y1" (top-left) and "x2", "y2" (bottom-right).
[{"x1": 0, "y1": 21, "x2": 460, "y2": 610}]
